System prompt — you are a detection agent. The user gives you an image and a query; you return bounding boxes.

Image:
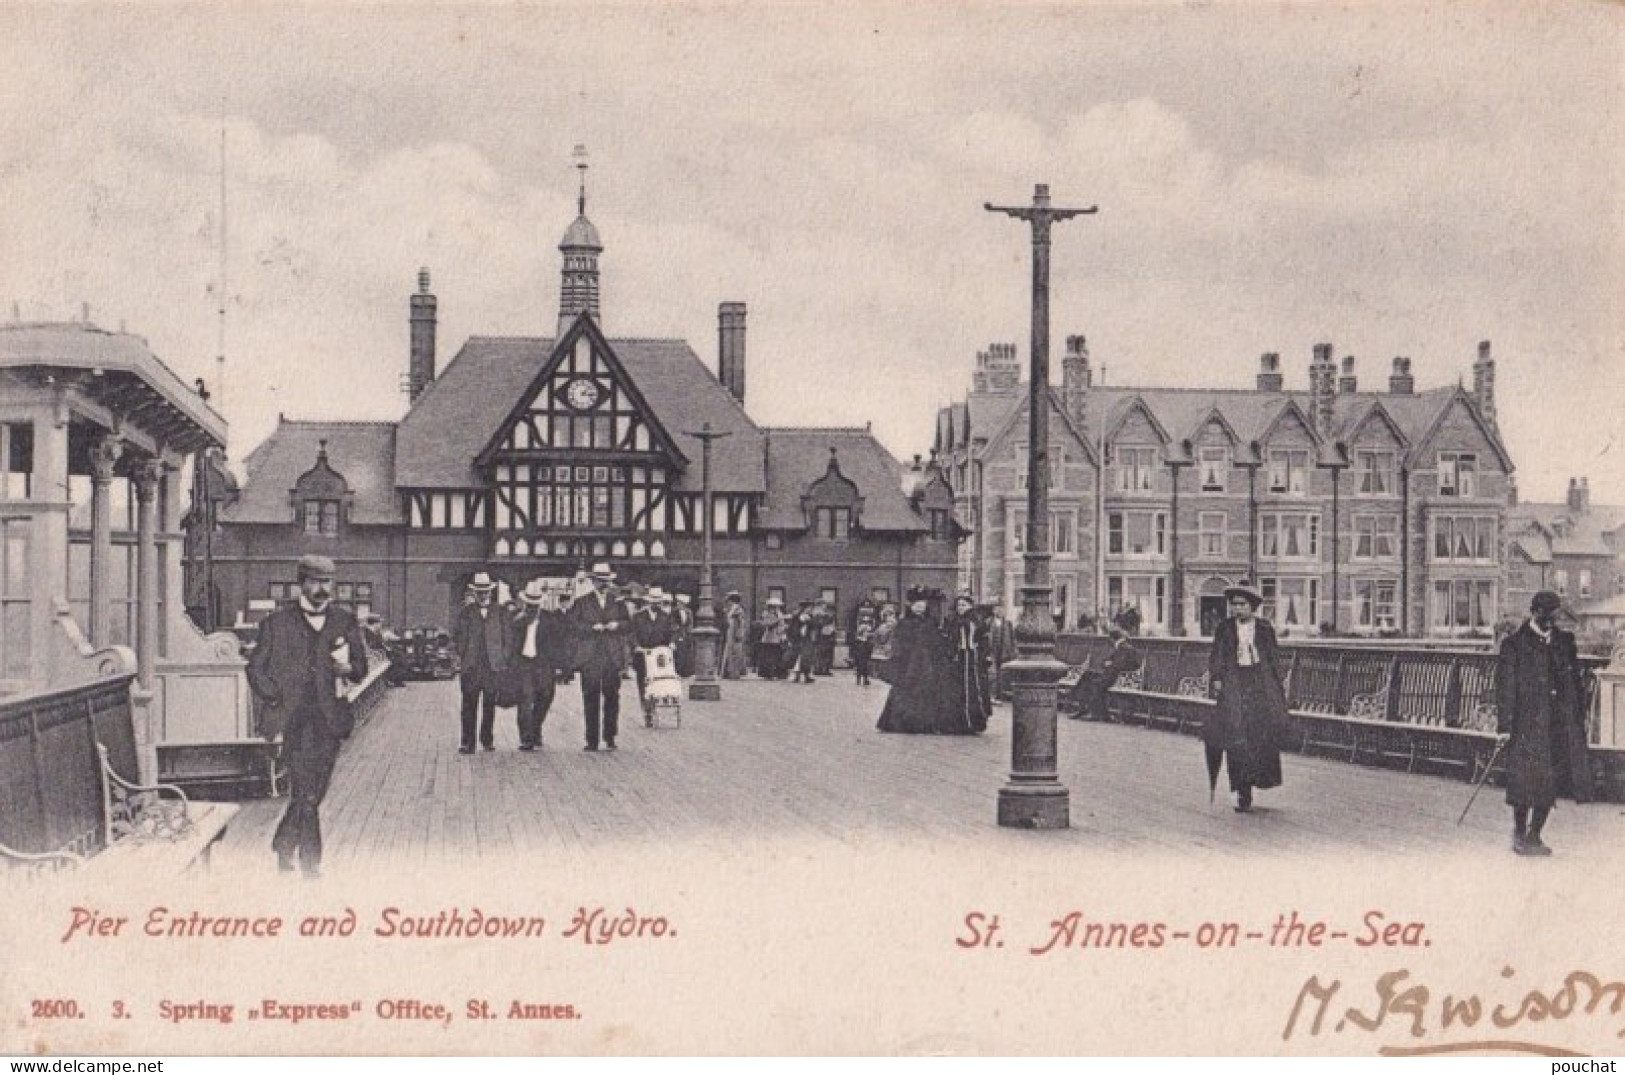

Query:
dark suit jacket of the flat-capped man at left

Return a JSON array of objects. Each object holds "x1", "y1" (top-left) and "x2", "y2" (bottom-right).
[{"x1": 247, "y1": 601, "x2": 367, "y2": 742}]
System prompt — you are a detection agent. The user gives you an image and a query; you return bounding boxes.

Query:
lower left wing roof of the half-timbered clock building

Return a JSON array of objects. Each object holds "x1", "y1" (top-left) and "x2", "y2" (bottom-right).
[{"x1": 219, "y1": 419, "x2": 401, "y2": 526}]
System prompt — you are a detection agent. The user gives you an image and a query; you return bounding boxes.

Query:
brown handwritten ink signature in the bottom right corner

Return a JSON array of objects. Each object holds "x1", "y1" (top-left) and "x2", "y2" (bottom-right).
[{"x1": 1281, "y1": 966, "x2": 1625, "y2": 1056}]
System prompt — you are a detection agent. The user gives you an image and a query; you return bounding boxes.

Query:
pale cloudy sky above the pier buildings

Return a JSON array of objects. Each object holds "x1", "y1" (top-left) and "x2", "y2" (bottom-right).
[{"x1": 0, "y1": 2, "x2": 1625, "y2": 503}]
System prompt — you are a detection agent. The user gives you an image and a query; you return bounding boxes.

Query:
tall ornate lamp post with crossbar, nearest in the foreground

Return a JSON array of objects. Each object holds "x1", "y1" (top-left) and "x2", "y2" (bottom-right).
[{"x1": 985, "y1": 183, "x2": 1095, "y2": 828}]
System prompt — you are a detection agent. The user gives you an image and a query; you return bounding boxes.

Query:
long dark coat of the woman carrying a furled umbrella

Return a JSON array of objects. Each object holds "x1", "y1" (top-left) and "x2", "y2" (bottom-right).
[{"x1": 1203, "y1": 617, "x2": 1290, "y2": 791}]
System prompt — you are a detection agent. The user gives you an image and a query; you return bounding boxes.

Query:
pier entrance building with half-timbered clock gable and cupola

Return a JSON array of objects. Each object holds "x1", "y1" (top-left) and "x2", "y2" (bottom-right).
[{"x1": 208, "y1": 195, "x2": 969, "y2": 625}]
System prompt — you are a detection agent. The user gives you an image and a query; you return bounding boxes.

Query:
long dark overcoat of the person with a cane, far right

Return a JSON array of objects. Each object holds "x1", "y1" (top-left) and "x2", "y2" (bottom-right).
[{"x1": 1495, "y1": 622, "x2": 1593, "y2": 807}]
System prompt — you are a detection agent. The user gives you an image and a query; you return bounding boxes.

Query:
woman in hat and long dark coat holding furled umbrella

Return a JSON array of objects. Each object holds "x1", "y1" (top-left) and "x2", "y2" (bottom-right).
[{"x1": 1203, "y1": 580, "x2": 1289, "y2": 814}]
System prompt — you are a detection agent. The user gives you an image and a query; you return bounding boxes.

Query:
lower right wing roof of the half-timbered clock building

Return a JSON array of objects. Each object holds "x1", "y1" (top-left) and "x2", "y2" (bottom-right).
[{"x1": 761, "y1": 427, "x2": 930, "y2": 533}]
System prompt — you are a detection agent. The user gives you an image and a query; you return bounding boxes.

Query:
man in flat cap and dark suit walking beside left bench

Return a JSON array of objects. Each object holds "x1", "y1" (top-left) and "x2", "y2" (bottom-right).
[{"x1": 247, "y1": 555, "x2": 367, "y2": 879}]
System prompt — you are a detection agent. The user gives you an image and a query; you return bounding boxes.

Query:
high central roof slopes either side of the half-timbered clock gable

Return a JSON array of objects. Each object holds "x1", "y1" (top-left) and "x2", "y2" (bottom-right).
[{"x1": 399, "y1": 336, "x2": 767, "y2": 492}]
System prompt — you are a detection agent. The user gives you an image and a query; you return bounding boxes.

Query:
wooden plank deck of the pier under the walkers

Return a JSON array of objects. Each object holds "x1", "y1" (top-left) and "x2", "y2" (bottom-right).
[{"x1": 215, "y1": 674, "x2": 1625, "y2": 872}]
